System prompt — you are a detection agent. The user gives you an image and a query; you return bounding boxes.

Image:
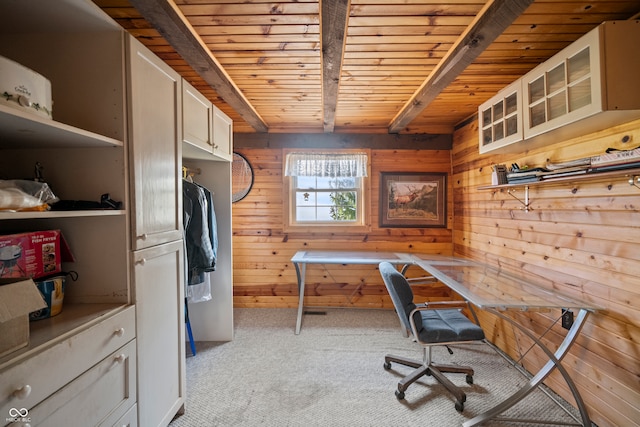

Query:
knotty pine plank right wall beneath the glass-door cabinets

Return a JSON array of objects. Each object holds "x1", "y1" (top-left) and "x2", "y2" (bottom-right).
[{"x1": 452, "y1": 117, "x2": 640, "y2": 427}]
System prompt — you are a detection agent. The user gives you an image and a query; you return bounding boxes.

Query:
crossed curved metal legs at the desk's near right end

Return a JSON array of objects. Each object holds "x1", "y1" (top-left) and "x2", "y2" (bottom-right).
[{"x1": 462, "y1": 309, "x2": 591, "y2": 427}]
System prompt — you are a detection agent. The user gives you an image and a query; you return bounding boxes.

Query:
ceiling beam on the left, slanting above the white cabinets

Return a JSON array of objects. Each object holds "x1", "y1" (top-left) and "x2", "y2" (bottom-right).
[{"x1": 130, "y1": 0, "x2": 269, "y2": 132}]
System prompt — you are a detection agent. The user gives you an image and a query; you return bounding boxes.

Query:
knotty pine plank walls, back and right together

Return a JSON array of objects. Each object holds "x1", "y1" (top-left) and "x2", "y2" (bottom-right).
[{"x1": 233, "y1": 121, "x2": 640, "y2": 427}]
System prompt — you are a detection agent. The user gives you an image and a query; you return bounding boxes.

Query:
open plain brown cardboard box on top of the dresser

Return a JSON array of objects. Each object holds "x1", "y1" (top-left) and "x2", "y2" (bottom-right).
[{"x1": 0, "y1": 279, "x2": 47, "y2": 357}]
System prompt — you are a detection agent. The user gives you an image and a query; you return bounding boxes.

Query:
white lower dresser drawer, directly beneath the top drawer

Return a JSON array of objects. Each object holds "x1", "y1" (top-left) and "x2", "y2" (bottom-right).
[{"x1": 18, "y1": 340, "x2": 136, "y2": 427}]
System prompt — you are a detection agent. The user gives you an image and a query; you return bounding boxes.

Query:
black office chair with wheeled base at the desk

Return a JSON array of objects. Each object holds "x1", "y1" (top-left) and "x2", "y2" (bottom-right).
[{"x1": 379, "y1": 262, "x2": 484, "y2": 412}]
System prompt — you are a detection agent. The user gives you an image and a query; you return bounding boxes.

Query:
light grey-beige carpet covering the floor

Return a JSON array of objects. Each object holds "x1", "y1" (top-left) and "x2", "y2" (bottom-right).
[{"x1": 170, "y1": 308, "x2": 573, "y2": 427}]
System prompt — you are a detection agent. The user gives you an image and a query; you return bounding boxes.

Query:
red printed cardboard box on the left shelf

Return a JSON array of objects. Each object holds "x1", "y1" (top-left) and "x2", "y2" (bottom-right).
[{"x1": 0, "y1": 230, "x2": 73, "y2": 279}]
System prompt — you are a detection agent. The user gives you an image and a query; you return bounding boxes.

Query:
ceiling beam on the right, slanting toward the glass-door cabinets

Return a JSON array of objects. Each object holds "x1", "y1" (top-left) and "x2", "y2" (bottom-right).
[{"x1": 389, "y1": 0, "x2": 533, "y2": 133}]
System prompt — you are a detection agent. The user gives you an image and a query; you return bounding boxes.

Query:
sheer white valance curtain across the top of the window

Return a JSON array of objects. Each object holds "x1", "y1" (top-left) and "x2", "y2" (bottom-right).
[{"x1": 284, "y1": 153, "x2": 367, "y2": 178}]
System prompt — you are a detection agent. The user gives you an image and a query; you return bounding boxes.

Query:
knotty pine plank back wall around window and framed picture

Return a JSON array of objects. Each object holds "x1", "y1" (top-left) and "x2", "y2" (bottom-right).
[{"x1": 233, "y1": 147, "x2": 453, "y2": 308}]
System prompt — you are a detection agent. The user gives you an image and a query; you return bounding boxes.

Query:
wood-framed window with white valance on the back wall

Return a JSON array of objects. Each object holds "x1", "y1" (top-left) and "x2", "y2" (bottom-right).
[{"x1": 285, "y1": 151, "x2": 368, "y2": 232}]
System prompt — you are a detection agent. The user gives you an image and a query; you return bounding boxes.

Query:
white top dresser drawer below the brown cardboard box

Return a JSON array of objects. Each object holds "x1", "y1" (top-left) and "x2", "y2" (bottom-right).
[{"x1": 0, "y1": 306, "x2": 135, "y2": 420}]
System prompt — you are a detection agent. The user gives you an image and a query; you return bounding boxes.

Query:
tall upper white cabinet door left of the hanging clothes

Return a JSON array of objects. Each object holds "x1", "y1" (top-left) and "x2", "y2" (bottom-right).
[{"x1": 127, "y1": 36, "x2": 182, "y2": 249}]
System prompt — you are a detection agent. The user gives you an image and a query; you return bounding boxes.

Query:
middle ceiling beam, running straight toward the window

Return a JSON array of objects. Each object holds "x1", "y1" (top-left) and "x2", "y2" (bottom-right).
[{"x1": 320, "y1": 0, "x2": 350, "y2": 132}]
